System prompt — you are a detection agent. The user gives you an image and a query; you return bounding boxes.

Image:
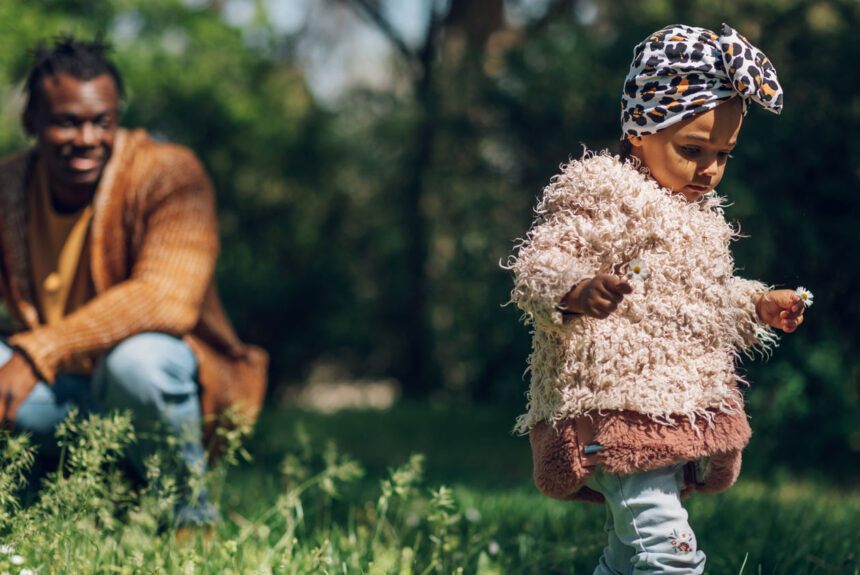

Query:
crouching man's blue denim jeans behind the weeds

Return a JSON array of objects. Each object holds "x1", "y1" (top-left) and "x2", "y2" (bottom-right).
[{"x1": 0, "y1": 333, "x2": 217, "y2": 524}]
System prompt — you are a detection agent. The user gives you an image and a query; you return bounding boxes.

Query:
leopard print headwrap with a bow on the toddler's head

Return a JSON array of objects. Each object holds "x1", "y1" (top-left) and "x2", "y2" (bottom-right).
[{"x1": 621, "y1": 24, "x2": 782, "y2": 136}]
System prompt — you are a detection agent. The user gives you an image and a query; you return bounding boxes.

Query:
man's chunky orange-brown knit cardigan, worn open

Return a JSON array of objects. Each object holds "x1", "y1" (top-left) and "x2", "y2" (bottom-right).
[{"x1": 0, "y1": 130, "x2": 268, "y2": 440}]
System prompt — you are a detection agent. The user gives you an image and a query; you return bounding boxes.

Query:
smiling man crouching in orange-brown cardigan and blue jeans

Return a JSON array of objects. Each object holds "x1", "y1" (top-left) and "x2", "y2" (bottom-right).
[{"x1": 0, "y1": 37, "x2": 267, "y2": 523}]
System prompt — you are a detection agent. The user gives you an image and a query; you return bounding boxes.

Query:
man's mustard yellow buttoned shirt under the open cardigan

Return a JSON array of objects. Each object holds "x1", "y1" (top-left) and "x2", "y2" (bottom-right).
[{"x1": 29, "y1": 165, "x2": 95, "y2": 373}]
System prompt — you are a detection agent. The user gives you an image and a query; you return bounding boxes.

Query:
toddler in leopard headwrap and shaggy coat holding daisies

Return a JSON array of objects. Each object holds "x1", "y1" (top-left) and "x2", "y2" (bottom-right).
[{"x1": 508, "y1": 24, "x2": 805, "y2": 575}]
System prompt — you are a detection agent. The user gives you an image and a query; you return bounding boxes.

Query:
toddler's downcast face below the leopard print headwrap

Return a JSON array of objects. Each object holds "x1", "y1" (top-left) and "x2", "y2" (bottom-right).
[{"x1": 630, "y1": 98, "x2": 743, "y2": 202}]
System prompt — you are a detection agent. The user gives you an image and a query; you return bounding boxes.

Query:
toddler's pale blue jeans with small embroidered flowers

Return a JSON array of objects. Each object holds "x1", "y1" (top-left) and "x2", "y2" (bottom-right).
[{"x1": 588, "y1": 463, "x2": 705, "y2": 575}]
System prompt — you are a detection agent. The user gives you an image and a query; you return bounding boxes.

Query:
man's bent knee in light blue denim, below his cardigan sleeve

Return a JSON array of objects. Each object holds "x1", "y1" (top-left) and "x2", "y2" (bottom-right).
[{"x1": 97, "y1": 333, "x2": 197, "y2": 409}]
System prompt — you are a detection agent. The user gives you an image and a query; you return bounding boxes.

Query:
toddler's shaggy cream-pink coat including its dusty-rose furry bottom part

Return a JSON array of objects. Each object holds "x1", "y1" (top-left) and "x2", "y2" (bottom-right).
[{"x1": 507, "y1": 152, "x2": 776, "y2": 502}]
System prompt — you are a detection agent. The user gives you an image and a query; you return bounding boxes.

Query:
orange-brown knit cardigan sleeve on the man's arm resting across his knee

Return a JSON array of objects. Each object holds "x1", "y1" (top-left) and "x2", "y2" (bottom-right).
[{"x1": 9, "y1": 147, "x2": 218, "y2": 382}]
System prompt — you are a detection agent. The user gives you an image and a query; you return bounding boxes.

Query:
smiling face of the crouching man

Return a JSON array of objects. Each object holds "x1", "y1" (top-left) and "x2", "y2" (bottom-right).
[{"x1": 28, "y1": 74, "x2": 119, "y2": 203}]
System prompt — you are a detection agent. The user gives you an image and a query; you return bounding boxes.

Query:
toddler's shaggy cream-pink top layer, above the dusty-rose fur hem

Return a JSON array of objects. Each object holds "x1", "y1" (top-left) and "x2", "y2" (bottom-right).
[{"x1": 507, "y1": 152, "x2": 776, "y2": 433}]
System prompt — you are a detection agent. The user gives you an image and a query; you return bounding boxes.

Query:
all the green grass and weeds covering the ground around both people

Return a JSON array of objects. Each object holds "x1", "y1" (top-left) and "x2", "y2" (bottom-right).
[{"x1": 0, "y1": 404, "x2": 860, "y2": 575}]
